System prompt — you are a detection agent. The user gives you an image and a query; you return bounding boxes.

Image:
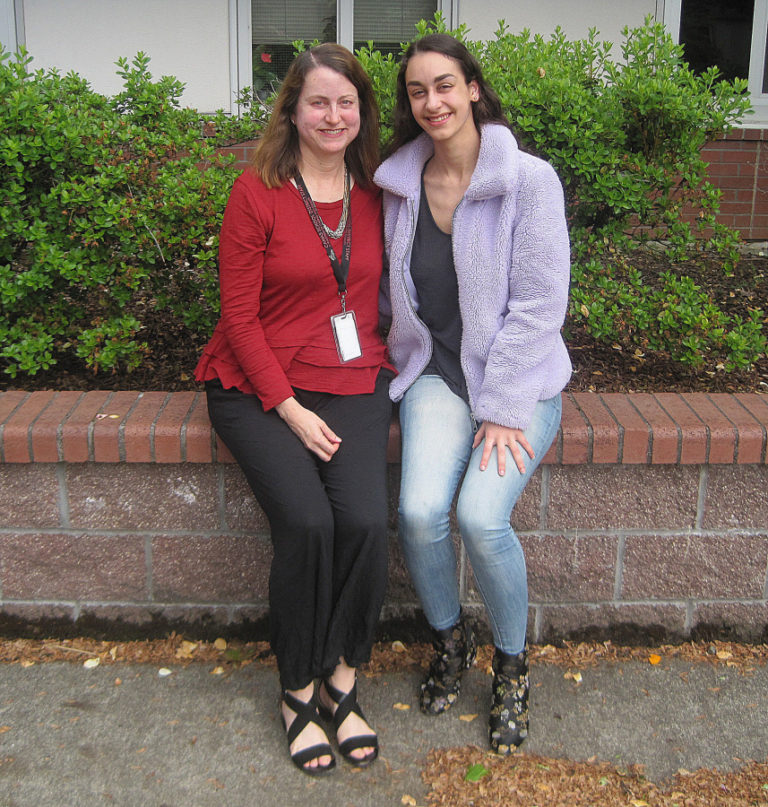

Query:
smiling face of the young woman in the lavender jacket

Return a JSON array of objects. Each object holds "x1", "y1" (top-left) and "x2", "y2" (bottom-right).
[{"x1": 405, "y1": 51, "x2": 479, "y2": 140}]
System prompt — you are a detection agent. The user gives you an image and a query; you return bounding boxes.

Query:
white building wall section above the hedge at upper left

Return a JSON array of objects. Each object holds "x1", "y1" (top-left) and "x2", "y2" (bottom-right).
[{"x1": 23, "y1": 0, "x2": 232, "y2": 112}]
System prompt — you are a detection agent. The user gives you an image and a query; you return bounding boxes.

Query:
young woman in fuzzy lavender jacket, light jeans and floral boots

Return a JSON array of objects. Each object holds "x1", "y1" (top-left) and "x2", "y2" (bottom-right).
[{"x1": 375, "y1": 34, "x2": 571, "y2": 754}]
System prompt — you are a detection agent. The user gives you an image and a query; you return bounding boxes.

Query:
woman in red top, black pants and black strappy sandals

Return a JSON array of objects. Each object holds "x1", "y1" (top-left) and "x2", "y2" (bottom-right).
[{"x1": 195, "y1": 44, "x2": 392, "y2": 774}]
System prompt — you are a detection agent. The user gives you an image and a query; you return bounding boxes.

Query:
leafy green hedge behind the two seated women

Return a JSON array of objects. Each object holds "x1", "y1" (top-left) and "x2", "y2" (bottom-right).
[{"x1": 0, "y1": 17, "x2": 766, "y2": 377}]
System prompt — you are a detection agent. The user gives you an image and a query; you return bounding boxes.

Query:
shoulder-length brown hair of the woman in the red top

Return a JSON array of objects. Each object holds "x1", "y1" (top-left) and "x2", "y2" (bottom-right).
[{"x1": 251, "y1": 42, "x2": 379, "y2": 188}]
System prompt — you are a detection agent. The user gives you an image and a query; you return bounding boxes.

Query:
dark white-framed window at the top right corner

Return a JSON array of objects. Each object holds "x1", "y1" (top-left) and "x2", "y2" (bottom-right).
[{"x1": 664, "y1": 0, "x2": 768, "y2": 126}]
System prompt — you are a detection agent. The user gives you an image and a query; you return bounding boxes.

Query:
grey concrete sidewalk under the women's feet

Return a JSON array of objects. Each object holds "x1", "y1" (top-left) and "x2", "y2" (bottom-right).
[{"x1": 0, "y1": 659, "x2": 768, "y2": 807}]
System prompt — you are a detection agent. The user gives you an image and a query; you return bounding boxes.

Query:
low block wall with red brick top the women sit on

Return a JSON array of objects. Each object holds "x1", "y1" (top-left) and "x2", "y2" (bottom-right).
[{"x1": 0, "y1": 392, "x2": 768, "y2": 641}]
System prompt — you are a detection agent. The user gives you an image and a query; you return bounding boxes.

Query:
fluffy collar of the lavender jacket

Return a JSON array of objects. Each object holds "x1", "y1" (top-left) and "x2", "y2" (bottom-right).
[{"x1": 374, "y1": 123, "x2": 520, "y2": 200}]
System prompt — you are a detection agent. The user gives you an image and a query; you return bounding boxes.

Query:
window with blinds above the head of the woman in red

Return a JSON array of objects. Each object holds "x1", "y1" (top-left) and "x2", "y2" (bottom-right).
[{"x1": 251, "y1": 0, "x2": 441, "y2": 98}]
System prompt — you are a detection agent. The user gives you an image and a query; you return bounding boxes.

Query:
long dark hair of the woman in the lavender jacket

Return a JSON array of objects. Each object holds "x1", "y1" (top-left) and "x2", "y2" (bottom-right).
[{"x1": 386, "y1": 34, "x2": 511, "y2": 156}]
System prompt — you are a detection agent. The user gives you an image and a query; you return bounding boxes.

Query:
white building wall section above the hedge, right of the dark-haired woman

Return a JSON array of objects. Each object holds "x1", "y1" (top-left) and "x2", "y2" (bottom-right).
[{"x1": 459, "y1": 0, "x2": 657, "y2": 44}]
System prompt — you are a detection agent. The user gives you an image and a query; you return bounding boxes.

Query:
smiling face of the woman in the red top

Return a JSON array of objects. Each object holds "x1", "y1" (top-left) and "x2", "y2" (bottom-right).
[{"x1": 292, "y1": 65, "x2": 360, "y2": 164}]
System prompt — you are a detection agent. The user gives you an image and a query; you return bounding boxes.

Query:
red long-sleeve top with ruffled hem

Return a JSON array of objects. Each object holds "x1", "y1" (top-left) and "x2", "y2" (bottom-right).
[{"x1": 195, "y1": 170, "x2": 391, "y2": 410}]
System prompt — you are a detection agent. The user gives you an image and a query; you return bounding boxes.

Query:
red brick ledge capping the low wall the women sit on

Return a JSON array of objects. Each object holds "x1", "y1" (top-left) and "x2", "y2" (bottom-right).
[{"x1": 0, "y1": 390, "x2": 768, "y2": 465}]
